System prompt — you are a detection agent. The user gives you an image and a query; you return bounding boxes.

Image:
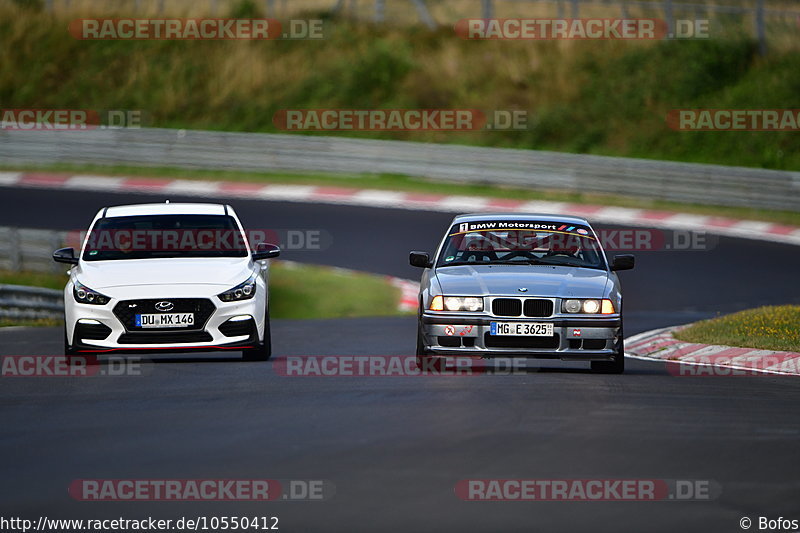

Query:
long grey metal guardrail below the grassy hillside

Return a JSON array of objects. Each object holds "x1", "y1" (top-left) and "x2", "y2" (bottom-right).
[{"x1": 0, "y1": 128, "x2": 800, "y2": 211}]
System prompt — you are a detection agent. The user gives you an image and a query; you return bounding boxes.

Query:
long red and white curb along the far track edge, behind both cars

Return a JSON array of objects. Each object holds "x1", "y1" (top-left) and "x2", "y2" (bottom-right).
[{"x1": 6, "y1": 172, "x2": 800, "y2": 245}]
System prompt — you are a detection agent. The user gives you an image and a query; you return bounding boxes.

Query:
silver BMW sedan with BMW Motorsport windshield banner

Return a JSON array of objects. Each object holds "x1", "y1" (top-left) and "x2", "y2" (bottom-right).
[{"x1": 409, "y1": 213, "x2": 634, "y2": 373}]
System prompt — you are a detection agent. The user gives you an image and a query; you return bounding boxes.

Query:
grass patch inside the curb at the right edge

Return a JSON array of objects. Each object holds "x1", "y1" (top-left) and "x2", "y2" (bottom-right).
[{"x1": 675, "y1": 305, "x2": 800, "y2": 352}]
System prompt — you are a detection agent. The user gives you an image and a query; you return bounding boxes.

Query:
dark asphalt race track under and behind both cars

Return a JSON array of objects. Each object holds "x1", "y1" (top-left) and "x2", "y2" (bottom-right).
[{"x1": 0, "y1": 185, "x2": 800, "y2": 532}]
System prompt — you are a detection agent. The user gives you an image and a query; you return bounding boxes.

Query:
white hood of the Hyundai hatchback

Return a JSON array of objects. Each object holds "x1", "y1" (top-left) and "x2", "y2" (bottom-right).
[{"x1": 75, "y1": 257, "x2": 251, "y2": 290}]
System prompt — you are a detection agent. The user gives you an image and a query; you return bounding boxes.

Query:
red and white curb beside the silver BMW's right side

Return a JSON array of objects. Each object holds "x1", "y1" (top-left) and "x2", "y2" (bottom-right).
[{"x1": 625, "y1": 326, "x2": 800, "y2": 376}]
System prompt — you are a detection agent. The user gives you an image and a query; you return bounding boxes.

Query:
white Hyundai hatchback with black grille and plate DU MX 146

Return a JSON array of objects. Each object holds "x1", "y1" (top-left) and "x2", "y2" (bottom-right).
[{"x1": 53, "y1": 203, "x2": 280, "y2": 360}]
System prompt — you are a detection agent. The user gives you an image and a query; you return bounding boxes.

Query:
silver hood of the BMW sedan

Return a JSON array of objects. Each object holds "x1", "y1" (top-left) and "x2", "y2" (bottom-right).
[{"x1": 436, "y1": 265, "x2": 608, "y2": 298}]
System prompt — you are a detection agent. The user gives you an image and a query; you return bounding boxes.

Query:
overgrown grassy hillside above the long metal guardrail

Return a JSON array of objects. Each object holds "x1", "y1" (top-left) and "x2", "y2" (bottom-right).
[{"x1": 0, "y1": 8, "x2": 800, "y2": 170}]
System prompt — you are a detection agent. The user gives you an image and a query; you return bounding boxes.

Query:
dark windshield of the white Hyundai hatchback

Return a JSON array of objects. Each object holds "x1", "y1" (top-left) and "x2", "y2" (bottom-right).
[{"x1": 83, "y1": 215, "x2": 247, "y2": 261}]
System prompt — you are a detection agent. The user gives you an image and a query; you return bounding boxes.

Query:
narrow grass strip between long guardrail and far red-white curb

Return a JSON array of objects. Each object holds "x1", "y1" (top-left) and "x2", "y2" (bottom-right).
[{"x1": 6, "y1": 164, "x2": 800, "y2": 226}]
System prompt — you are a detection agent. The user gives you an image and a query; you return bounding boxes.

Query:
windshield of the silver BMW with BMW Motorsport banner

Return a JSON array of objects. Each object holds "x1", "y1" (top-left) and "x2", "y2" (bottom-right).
[{"x1": 436, "y1": 220, "x2": 606, "y2": 270}]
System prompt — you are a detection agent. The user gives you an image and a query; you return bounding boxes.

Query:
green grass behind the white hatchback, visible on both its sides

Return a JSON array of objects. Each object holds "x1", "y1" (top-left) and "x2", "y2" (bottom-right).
[{"x1": 0, "y1": 262, "x2": 402, "y2": 326}]
